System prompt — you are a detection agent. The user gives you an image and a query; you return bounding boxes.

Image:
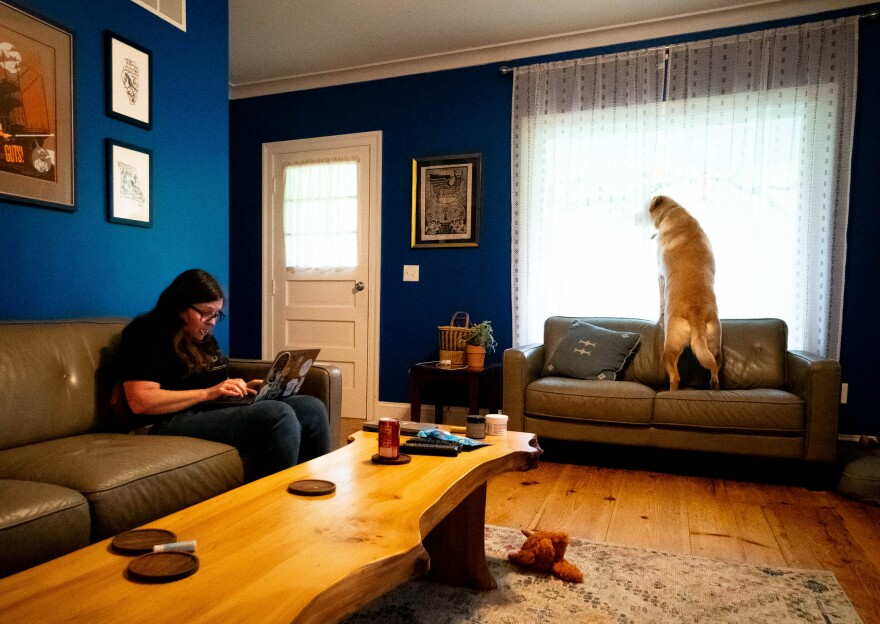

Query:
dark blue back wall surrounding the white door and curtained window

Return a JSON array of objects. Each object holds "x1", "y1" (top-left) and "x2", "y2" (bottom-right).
[{"x1": 230, "y1": 6, "x2": 880, "y2": 433}]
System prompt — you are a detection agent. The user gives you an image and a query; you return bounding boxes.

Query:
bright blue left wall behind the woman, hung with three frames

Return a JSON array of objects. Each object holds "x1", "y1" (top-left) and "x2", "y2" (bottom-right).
[{"x1": 0, "y1": 0, "x2": 229, "y2": 343}]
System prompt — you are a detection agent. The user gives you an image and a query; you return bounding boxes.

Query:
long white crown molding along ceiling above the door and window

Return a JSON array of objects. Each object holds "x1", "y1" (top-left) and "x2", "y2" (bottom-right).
[{"x1": 229, "y1": 0, "x2": 865, "y2": 100}]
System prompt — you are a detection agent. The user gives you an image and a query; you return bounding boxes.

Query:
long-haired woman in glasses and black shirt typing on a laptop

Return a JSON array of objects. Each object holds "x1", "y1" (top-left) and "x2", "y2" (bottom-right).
[{"x1": 119, "y1": 269, "x2": 330, "y2": 480}]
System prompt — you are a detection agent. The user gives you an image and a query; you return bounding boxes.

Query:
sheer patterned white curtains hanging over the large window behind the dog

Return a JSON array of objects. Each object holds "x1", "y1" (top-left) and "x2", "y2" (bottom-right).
[{"x1": 511, "y1": 18, "x2": 858, "y2": 357}]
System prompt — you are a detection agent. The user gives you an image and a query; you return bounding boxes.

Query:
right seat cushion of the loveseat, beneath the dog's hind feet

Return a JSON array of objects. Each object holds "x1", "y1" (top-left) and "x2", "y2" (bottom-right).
[{"x1": 654, "y1": 389, "x2": 805, "y2": 435}]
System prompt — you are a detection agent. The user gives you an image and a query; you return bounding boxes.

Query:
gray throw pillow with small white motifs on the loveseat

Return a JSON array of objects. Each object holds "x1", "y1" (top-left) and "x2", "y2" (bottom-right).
[{"x1": 544, "y1": 321, "x2": 642, "y2": 380}]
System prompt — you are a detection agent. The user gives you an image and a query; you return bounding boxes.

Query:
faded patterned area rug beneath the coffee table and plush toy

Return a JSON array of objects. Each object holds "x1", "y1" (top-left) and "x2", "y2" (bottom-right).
[{"x1": 345, "y1": 526, "x2": 862, "y2": 624}]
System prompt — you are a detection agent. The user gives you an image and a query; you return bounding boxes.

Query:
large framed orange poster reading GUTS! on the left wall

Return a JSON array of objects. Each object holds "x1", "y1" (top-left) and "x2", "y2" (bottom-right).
[{"x1": 0, "y1": 2, "x2": 76, "y2": 211}]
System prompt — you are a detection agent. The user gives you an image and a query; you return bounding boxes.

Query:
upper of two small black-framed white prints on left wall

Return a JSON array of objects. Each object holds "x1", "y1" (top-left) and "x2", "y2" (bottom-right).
[{"x1": 104, "y1": 30, "x2": 153, "y2": 130}]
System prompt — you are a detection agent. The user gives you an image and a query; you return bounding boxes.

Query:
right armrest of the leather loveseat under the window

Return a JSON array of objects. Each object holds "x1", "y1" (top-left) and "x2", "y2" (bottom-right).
[{"x1": 785, "y1": 351, "x2": 840, "y2": 463}]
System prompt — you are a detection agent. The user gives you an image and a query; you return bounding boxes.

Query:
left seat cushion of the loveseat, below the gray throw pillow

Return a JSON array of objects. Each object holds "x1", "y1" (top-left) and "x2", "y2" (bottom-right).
[{"x1": 525, "y1": 377, "x2": 654, "y2": 425}]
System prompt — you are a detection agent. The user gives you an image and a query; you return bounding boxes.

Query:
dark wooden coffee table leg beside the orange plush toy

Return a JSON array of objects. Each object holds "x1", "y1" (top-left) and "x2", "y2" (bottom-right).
[{"x1": 422, "y1": 483, "x2": 496, "y2": 590}]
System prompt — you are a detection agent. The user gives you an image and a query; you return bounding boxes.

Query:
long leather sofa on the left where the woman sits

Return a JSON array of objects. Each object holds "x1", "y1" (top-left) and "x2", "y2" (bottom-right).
[{"x1": 0, "y1": 319, "x2": 342, "y2": 577}]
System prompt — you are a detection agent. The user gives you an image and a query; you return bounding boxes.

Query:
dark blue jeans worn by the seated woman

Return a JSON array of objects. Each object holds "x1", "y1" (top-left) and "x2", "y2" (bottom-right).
[{"x1": 150, "y1": 395, "x2": 330, "y2": 481}]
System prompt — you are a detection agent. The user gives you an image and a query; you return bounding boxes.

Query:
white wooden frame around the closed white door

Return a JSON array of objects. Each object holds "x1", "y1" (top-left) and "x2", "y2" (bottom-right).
[{"x1": 261, "y1": 130, "x2": 382, "y2": 418}]
